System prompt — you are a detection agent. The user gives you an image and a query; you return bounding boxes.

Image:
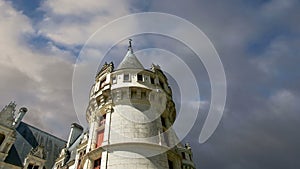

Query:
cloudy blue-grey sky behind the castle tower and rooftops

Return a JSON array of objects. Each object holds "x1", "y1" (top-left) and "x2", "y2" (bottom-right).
[{"x1": 0, "y1": 0, "x2": 300, "y2": 169}]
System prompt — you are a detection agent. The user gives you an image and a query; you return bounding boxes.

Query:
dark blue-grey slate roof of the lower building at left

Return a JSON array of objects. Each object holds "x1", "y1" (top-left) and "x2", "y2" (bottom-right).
[{"x1": 5, "y1": 122, "x2": 66, "y2": 169}]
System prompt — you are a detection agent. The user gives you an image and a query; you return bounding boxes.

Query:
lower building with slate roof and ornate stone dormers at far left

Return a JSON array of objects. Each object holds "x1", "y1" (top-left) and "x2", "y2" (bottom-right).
[{"x1": 0, "y1": 102, "x2": 66, "y2": 169}]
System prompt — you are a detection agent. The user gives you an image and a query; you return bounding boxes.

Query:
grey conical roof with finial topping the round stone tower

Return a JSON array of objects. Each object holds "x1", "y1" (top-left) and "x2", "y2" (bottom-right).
[{"x1": 117, "y1": 39, "x2": 144, "y2": 69}]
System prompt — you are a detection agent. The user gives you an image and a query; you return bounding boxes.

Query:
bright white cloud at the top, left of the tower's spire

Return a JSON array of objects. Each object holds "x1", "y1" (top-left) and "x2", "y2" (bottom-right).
[{"x1": 39, "y1": 0, "x2": 130, "y2": 45}]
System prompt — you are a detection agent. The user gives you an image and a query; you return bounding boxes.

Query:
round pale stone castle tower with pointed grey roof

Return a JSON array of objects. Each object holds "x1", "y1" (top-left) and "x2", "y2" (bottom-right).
[{"x1": 70, "y1": 40, "x2": 195, "y2": 169}]
